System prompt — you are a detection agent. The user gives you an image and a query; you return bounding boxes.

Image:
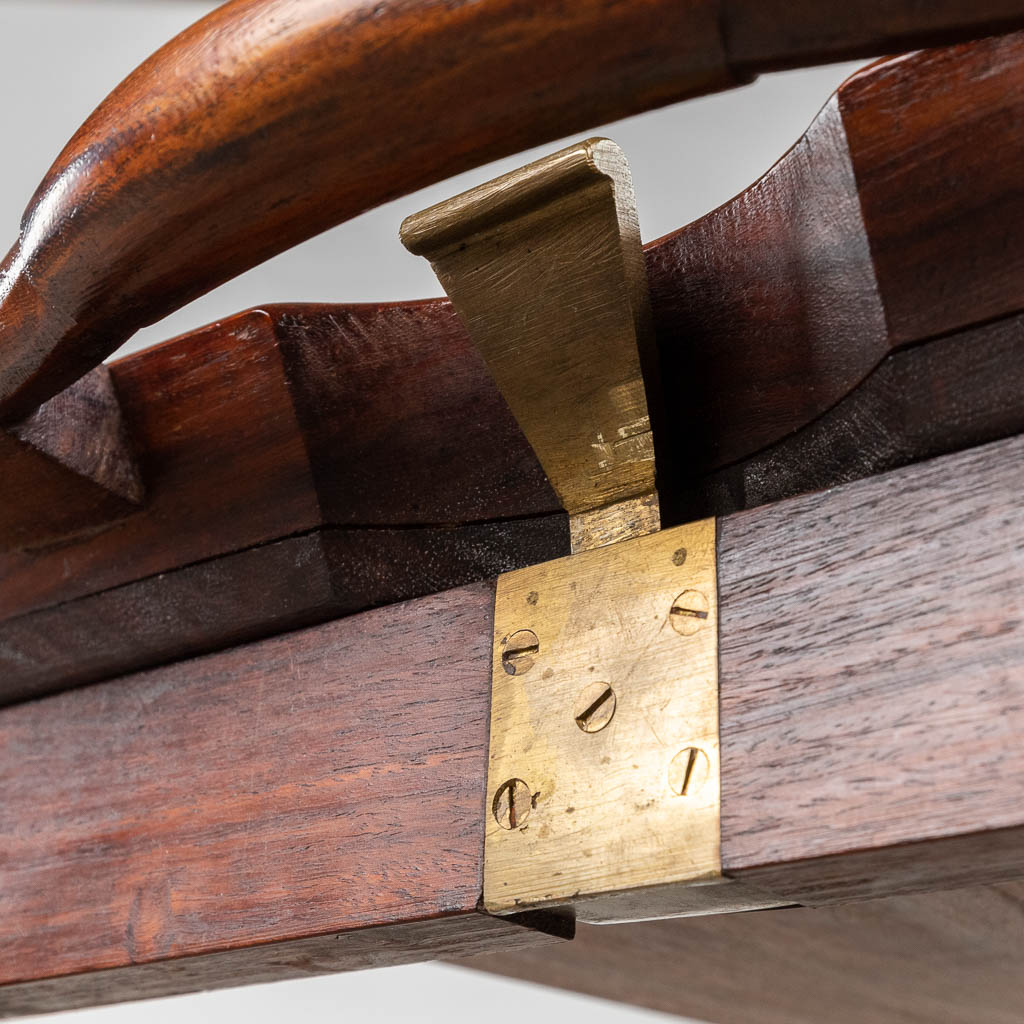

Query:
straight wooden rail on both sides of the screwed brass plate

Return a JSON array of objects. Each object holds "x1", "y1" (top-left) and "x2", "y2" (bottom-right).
[{"x1": 0, "y1": 438, "x2": 1024, "y2": 1020}]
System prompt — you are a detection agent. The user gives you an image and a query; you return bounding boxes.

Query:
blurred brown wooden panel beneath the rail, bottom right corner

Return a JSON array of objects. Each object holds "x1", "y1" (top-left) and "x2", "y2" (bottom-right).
[{"x1": 462, "y1": 883, "x2": 1024, "y2": 1024}]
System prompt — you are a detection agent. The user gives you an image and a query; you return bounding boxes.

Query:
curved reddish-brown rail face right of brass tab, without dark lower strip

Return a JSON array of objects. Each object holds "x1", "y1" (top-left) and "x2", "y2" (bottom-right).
[{"x1": 647, "y1": 29, "x2": 1024, "y2": 493}]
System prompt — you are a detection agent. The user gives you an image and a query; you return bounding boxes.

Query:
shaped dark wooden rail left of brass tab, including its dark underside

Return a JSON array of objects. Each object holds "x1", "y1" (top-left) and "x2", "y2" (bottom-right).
[{"x1": 0, "y1": 303, "x2": 568, "y2": 700}]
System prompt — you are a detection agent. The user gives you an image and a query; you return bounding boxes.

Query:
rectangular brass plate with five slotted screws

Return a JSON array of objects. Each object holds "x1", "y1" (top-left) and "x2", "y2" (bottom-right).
[{"x1": 483, "y1": 519, "x2": 737, "y2": 921}]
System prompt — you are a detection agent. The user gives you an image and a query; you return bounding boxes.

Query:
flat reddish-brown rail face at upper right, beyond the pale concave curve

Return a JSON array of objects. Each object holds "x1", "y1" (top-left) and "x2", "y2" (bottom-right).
[{"x1": 840, "y1": 36, "x2": 1024, "y2": 345}]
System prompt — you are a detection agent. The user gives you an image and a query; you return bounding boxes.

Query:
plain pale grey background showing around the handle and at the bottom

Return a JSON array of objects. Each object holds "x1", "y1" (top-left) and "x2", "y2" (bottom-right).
[{"x1": 0, "y1": 0, "x2": 855, "y2": 1024}]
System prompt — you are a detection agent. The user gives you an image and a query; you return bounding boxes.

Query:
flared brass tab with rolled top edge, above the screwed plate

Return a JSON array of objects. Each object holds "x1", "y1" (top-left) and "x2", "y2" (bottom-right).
[{"x1": 401, "y1": 138, "x2": 660, "y2": 551}]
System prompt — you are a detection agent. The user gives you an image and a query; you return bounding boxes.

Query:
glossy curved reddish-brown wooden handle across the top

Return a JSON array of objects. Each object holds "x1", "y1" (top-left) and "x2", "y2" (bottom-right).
[{"x1": 0, "y1": 0, "x2": 1024, "y2": 422}]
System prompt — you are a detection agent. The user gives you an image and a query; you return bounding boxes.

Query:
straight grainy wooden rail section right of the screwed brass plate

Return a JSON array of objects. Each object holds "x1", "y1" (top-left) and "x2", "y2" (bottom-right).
[{"x1": 719, "y1": 438, "x2": 1024, "y2": 903}]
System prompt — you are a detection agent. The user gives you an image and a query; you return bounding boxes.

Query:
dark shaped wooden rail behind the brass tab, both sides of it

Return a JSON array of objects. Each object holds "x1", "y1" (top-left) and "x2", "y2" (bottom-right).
[{"x1": 0, "y1": 36, "x2": 1024, "y2": 700}]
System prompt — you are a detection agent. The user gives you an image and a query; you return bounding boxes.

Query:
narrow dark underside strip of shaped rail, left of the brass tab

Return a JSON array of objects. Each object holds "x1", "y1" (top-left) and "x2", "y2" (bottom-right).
[{"x1": 0, "y1": 516, "x2": 568, "y2": 702}]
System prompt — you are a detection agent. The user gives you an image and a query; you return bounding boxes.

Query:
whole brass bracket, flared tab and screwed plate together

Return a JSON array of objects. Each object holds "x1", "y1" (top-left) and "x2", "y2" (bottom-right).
[{"x1": 401, "y1": 139, "x2": 775, "y2": 923}]
